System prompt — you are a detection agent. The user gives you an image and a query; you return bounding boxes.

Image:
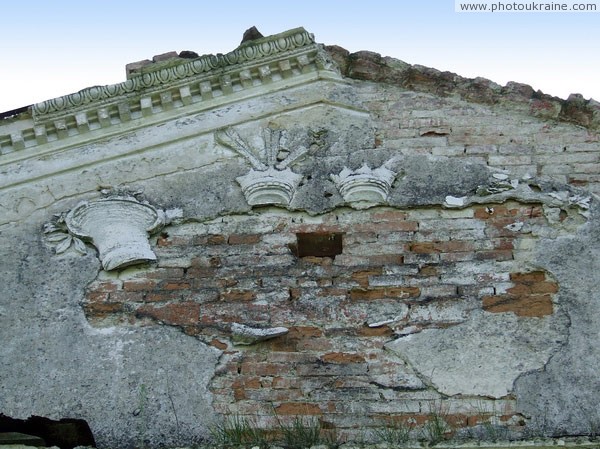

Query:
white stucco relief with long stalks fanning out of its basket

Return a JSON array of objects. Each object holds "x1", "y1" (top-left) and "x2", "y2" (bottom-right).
[{"x1": 215, "y1": 127, "x2": 319, "y2": 206}]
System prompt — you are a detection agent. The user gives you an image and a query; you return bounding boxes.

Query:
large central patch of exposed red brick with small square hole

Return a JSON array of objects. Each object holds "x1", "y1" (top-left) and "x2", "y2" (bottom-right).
[{"x1": 84, "y1": 202, "x2": 559, "y2": 437}]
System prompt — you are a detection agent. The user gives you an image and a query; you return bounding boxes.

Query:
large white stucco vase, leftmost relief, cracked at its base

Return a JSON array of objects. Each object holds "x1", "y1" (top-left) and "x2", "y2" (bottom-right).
[{"x1": 64, "y1": 197, "x2": 165, "y2": 271}]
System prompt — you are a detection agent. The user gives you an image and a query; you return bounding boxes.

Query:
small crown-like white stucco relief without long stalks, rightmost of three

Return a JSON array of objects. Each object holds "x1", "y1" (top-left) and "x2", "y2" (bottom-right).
[{"x1": 331, "y1": 163, "x2": 396, "y2": 209}]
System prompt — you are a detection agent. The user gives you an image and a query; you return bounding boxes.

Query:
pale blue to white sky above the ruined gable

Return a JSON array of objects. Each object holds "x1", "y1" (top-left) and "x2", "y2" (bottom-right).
[{"x1": 0, "y1": 0, "x2": 600, "y2": 111}]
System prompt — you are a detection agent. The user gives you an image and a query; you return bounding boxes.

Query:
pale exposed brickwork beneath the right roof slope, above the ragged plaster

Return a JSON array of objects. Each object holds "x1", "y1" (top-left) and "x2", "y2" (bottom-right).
[{"x1": 359, "y1": 84, "x2": 600, "y2": 193}]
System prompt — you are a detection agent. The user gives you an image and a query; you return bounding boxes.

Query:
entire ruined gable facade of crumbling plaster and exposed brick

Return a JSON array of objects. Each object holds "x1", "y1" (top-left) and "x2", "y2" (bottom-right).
[{"x1": 0, "y1": 29, "x2": 600, "y2": 447}]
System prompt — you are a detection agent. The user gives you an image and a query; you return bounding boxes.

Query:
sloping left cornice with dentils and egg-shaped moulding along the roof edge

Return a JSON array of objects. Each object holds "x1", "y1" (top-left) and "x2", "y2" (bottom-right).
[{"x1": 0, "y1": 28, "x2": 338, "y2": 157}]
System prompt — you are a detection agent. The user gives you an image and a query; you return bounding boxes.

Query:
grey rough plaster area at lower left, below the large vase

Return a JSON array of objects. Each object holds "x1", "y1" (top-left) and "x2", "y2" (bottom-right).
[{"x1": 0, "y1": 219, "x2": 218, "y2": 447}]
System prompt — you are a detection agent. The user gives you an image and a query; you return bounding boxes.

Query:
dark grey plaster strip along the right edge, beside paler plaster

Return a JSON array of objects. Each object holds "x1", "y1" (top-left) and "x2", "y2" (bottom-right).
[{"x1": 515, "y1": 207, "x2": 600, "y2": 435}]
